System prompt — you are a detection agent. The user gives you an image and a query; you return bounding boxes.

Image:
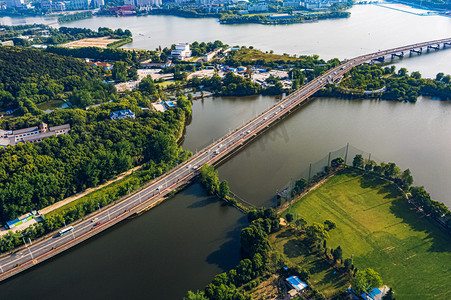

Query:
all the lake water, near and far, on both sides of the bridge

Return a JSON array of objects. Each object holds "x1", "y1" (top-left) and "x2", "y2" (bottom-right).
[{"x1": 0, "y1": 5, "x2": 451, "y2": 299}]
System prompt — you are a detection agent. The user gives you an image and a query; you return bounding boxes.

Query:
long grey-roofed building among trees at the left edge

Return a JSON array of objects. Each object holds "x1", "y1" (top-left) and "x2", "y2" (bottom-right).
[{"x1": 0, "y1": 123, "x2": 70, "y2": 147}]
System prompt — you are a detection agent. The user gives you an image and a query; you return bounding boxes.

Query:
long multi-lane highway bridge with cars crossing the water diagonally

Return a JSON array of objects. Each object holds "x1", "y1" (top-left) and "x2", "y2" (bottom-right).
[{"x1": 0, "y1": 38, "x2": 451, "y2": 280}]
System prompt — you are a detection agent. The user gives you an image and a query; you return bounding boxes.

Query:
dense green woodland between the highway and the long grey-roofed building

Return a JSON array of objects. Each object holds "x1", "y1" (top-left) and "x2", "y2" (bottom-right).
[{"x1": 0, "y1": 95, "x2": 189, "y2": 222}]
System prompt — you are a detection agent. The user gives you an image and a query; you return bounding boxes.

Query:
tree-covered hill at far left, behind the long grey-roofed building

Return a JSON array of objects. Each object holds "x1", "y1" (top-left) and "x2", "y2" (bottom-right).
[{"x1": 0, "y1": 47, "x2": 116, "y2": 110}]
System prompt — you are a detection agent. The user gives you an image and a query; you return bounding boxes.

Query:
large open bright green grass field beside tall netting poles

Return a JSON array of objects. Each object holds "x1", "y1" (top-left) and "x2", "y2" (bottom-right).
[{"x1": 291, "y1": 170, "x2": 451, "y2": 300}]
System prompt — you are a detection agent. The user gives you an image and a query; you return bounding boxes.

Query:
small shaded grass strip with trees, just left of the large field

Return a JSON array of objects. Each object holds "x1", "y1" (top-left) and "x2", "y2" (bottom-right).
[{"x1": 270, "y1": 229, "x2": 349, "y2": 297}]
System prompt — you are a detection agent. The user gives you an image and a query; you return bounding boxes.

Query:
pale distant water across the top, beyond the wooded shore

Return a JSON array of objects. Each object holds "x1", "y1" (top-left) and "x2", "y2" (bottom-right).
[{"x1": 0, "y1": 5, "x2": 451, "y2": 77}]
